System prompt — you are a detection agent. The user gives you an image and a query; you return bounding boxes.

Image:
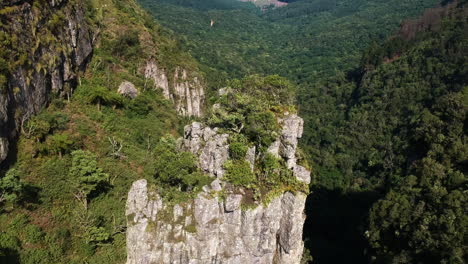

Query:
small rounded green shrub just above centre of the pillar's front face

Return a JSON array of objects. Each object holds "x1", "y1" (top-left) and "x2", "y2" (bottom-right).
[{"x1": 224, "y1": 160, "x2": 257, "y2": 187}]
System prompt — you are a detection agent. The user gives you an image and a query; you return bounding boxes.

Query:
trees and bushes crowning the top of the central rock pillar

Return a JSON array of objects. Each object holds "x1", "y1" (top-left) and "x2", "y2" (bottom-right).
[{"x1": 206, "y1": 75, "x2": 308, "y2": 206}]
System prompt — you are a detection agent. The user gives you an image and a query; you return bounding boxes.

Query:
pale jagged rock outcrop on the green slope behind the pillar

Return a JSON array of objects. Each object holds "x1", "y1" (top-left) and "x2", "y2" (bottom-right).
[{"x1": 145, "y1": 60, "x2": 205, "y2": 117}]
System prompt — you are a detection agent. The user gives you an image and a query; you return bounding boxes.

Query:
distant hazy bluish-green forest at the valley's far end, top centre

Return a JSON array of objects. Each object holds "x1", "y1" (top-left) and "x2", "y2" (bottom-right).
[{"x1": 139, "y1": 0, "x2": 437, "y2": 88}]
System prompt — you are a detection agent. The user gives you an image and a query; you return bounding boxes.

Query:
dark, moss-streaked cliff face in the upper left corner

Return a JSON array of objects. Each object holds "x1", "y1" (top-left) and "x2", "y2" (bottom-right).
[{"x1": 0, "y1": 0, "x2": 93, "y2": 165}]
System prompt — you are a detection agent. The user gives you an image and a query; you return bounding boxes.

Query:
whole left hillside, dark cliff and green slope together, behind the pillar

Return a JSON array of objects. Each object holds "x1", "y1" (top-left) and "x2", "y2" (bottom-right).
[{"x1": 0, "y1": 0, "x2": 203, "y2": 264}]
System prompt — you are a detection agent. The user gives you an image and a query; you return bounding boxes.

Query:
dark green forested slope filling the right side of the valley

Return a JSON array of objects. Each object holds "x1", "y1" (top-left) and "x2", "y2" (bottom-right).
[{"x1": 300, "y1": 3, "x2": 468, "y2": 263}]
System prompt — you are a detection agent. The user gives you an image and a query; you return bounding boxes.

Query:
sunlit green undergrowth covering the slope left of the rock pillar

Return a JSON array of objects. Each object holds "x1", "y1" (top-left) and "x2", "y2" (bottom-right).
[{"x1": 0, "y1": 0, "x2": 206, "y2": 263}]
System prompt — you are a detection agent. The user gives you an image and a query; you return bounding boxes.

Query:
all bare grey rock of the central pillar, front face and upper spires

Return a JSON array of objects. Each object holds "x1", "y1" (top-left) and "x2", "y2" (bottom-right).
[{"x1": 126, "y1": 114, "x2": 310, "y2": 264}]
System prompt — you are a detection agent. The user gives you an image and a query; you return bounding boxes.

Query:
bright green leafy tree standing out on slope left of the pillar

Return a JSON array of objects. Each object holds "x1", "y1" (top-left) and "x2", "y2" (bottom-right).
[{"x1": 69, "y1": 150, "x2": 109, "y2": 209}]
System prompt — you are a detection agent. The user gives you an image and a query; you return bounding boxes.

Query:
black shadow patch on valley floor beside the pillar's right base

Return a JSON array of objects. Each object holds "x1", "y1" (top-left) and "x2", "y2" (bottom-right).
[{"x1": 304, "y1": 189, "x2": 378, "y2": 264}]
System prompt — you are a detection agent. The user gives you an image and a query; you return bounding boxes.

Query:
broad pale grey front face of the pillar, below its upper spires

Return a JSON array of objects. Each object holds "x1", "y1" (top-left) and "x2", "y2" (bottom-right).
[{"x1": 126, "y1": 180, "x2": 306, "y2": 264}]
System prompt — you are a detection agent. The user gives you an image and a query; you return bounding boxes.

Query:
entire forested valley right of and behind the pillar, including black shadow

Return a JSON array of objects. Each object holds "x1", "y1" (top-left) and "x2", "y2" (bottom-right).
[{"x1": 140, "y1": 0, "x2": 468, "y2": 263}]
